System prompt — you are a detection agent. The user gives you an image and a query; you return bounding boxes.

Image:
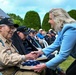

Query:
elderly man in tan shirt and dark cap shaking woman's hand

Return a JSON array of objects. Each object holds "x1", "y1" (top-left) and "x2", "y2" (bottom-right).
[{"x1": 0, "y1": 18, "x2": 36, "y2": 75}]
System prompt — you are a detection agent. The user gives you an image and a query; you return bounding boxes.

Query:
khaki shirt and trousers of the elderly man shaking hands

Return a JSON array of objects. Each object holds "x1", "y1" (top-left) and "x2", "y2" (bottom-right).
[{"x1": 0, "y1": 34, "x2": 44, "y2": 75}]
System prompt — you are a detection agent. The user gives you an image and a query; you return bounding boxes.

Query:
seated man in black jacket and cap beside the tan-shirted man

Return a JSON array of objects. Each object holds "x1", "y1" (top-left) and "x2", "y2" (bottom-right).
[{"x1": 12, "y1": 26, "x2": 36, "y2": 55}]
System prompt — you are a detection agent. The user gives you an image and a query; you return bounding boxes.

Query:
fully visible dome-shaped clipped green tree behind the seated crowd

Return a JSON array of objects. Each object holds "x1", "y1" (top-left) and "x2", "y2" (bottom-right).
[{"x1": 23, "y1": 11, "x2": 41, "y2": 30}]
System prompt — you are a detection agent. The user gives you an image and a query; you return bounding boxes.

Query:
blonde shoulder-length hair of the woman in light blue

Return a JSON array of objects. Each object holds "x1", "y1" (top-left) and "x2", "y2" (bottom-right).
[{"x1": 49, "y1": 8, "x2": 76, "y2": 31}]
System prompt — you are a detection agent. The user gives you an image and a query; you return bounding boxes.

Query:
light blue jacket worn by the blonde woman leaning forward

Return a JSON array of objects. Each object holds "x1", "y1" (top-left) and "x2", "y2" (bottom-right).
[{"x1": 42, "y1": 23, "x2": 76, "y2": 69}]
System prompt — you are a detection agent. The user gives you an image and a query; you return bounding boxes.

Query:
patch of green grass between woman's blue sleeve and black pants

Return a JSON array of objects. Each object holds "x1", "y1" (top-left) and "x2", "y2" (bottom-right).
[{"x1": 59, "y1": 57, "x2": 74, "y2": 71}]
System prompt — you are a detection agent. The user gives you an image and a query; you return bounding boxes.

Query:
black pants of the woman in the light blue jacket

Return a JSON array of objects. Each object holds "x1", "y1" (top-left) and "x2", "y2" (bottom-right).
[{"x1": 66, "y1": 60, "x2": 76, "y2": 75}]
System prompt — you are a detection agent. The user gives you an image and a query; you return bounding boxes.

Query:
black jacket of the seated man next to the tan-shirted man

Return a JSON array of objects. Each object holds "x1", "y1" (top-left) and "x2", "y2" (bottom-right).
[{"x1": 12, "y1": 32, "x2": 37, "y2": 55}]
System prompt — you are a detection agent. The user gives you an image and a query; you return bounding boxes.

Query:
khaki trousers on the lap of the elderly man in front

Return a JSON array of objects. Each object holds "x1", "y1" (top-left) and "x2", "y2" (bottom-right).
[{"x1": 1, "y1": 68, "x2": 45, "y2": 75}]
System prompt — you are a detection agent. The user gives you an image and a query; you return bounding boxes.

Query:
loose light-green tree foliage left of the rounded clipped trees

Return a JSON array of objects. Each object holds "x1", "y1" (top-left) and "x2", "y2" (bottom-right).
[{"x1": 8, "y1": 13, "x2": 23, "y2": 25}]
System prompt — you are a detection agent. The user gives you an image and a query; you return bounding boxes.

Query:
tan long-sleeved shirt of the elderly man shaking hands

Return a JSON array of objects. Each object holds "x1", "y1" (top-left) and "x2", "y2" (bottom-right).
[{"x1": 0, "y1": 34, "x2": 24, "y2": 75}]
